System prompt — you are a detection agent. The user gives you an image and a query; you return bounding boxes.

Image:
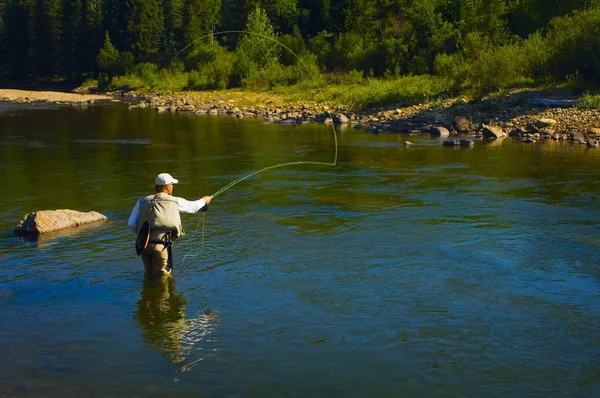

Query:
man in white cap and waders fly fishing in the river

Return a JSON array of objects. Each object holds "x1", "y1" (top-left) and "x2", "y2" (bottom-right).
[{"x1": 127, "y1": 173, "x2": 212, "y2": 278}]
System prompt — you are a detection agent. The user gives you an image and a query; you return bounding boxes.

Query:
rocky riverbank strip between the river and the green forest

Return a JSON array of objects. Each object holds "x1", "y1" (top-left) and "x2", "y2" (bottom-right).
[{"x1": 0, "y1": 86, "x2": 600, "y2": 146}]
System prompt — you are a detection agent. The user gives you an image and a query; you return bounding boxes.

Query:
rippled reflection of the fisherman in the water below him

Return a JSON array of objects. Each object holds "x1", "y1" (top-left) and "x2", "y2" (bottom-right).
[{"x1": 135, "y1": 277, "x2": 216, "y2": 371}]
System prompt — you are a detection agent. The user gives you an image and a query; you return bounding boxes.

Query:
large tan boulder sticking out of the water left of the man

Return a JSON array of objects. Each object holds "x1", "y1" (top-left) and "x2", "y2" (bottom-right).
[{"x1": 14, "y1": 209, "x2": 107, "y2": 236}]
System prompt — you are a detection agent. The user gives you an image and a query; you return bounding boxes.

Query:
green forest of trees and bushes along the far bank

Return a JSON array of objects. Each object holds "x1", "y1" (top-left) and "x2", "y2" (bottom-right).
[{"x1": 0, "y1": 0, "x2": 600, "y2": 97}]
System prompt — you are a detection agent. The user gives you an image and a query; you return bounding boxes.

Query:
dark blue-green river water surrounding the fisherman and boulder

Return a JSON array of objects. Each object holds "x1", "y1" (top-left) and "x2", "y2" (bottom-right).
[{"x1": 0, "y1": 105, "x2": 600, "y2": 397}]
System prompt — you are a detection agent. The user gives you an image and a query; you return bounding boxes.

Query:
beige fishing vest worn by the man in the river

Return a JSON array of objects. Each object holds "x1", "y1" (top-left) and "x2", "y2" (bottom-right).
[{"x1": 137, "y1": 192, "x2": 185, "y2": 240}]
